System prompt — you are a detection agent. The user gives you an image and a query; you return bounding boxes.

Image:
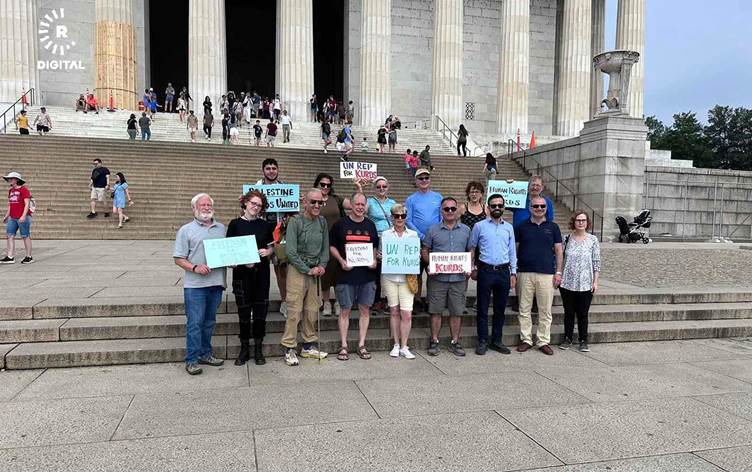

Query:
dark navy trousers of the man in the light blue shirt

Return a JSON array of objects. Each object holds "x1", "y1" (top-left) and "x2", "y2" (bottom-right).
[{"x1": 477, "y1": 264, "x2": 509, "y2": 344}]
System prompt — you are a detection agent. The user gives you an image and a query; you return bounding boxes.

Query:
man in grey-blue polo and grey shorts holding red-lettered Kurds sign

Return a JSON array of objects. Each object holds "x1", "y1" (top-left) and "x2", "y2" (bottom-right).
[{"x1": 422, "y1": 197, "x2": 470, "y2": 356}]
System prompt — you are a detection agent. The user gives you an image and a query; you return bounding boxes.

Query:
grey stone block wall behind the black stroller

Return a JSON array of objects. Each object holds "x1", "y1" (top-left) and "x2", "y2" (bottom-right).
[{"x1": 644, "y1": 165, "x2": 752, "y2": 240}]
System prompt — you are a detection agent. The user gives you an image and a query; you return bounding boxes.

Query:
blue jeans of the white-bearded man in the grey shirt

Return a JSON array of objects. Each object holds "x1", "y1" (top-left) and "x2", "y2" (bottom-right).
[{"x1": 183, "y1": 285, "x2": 224, "y2": 364}]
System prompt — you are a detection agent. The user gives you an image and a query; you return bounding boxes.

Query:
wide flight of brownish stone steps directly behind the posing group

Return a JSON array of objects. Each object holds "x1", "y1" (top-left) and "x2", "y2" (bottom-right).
[{"x1": 0, "y1": 135, "x2": 569, "y2": 240}]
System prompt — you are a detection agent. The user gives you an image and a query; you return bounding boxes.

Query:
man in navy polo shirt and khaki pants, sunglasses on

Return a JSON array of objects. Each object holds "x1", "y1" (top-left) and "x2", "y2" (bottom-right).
[{"x1": 514, "y1": 197, "x2": 563, "y2": 356}]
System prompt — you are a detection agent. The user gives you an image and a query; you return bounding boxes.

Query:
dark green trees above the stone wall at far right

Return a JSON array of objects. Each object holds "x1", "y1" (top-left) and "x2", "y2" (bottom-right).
[{"x1": 645, "y1": 105, "x2": 752, "y2": 170}]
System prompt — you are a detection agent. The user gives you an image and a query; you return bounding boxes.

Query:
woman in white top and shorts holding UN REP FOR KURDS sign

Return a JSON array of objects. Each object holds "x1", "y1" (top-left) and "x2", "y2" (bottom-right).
[{"x1": 381, "y1": 203, "x2": 420, "y2": 359}]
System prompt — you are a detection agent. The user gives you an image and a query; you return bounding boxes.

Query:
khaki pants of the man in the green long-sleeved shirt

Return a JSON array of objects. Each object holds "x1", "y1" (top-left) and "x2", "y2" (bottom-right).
[{"x1": 282, "y1": 266, "x2": 320, "y2": 348}]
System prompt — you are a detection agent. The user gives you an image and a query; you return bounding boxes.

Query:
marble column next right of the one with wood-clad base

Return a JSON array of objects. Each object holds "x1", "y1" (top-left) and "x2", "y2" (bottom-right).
[{"x1": 188, "y1": 0, "x2": 227, "y2": 110}]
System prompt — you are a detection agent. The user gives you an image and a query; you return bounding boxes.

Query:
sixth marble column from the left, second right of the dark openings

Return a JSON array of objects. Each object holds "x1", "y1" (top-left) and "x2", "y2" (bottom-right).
[{"x1": 431, "y1": 0, "x2": 464, "y2": 129}]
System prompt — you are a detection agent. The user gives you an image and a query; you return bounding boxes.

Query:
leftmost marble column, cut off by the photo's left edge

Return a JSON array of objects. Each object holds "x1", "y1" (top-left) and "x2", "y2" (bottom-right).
[{"x1": 0, "y1": 0, "x2": 39, "y2": 103}]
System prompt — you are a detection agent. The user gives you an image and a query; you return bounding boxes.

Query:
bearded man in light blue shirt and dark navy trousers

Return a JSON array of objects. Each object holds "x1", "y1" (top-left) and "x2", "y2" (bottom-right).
[{"x1": 470, "y1": 193, "x2": 517, "y2": 356}]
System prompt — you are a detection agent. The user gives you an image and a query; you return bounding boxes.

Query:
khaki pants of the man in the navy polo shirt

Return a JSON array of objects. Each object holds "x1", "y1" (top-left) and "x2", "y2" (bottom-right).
[{"x1": 517, "y1": 272, "x2": 554, "y2": 346}]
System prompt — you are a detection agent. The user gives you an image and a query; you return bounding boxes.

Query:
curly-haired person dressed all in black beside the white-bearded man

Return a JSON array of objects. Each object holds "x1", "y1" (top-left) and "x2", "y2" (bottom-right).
[{"x1": 227, "y1": 190, "x2": 274, "y2": 365}]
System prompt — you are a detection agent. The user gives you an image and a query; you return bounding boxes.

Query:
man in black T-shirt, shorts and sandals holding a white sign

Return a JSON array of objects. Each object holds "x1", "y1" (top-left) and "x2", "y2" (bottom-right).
[{"x1": 329, "y1": 192, "x2": 379, "y2": 361}]
